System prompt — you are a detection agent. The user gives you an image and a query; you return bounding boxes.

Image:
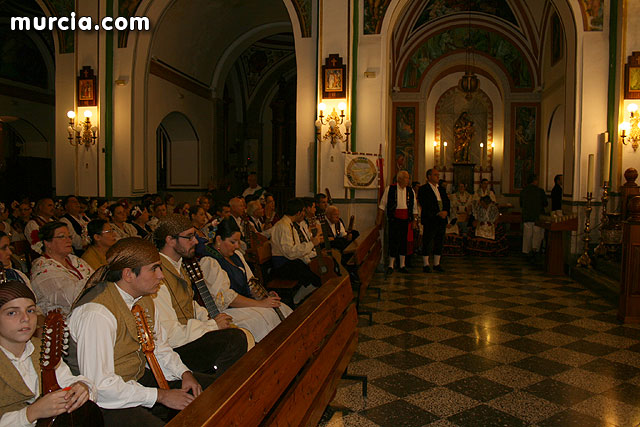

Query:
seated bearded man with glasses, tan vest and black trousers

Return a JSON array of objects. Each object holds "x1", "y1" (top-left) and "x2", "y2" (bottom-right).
[{"x1": 153, "y1": 214, "x2": 249, "y2": 376}]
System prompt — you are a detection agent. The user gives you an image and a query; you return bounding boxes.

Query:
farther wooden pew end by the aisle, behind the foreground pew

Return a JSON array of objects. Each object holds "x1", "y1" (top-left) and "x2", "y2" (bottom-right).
[{"x1": 342, "y1": 226, "x2": 382, "y2": 324}]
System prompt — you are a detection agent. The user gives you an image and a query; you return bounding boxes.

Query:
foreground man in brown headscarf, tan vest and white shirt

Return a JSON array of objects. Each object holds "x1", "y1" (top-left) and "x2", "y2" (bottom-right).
[{"x1": 67, "y1": 237, "x2": 213, "y2": 426}]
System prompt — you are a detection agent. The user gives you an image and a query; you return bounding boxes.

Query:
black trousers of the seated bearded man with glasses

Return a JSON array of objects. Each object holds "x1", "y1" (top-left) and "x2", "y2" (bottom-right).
[{"x1": 174, "y1": 328, "x2": 247, "y2": 378}]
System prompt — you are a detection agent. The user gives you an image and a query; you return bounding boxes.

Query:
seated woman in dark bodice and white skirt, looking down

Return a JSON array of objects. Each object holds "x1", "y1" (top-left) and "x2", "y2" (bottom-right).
[{"x1": 200, "y1": 218, "x2": 292, "y2": 341}]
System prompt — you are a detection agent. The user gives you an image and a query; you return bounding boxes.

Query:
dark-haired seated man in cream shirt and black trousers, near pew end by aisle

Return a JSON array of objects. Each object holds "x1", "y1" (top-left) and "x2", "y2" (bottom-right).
[{"x1": 271, "y1": 198, "x2": 322, "y2": 304}]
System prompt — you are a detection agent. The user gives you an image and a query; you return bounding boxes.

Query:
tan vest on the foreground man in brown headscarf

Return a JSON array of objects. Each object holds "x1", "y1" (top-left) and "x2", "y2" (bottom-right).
[{"x1": 65, "y1": 282, "x2": 155, "y2": 382}]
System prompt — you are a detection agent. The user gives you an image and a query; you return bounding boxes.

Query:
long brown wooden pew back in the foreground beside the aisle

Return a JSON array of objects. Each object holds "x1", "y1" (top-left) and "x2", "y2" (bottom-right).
[{"x1": 168, "y1": 275, "x2": 358, "y2": 427}]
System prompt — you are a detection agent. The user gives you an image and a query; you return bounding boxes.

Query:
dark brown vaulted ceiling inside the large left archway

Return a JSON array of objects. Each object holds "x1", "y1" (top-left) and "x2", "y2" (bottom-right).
[{"x1": 151, "y1": 0, "x2": 290, "y2": 85}]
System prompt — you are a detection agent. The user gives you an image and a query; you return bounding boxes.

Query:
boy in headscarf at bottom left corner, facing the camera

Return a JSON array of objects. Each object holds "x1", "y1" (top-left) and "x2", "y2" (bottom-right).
[{"x1": 0, "y1": 281, "x2": 95, "y2": 427}]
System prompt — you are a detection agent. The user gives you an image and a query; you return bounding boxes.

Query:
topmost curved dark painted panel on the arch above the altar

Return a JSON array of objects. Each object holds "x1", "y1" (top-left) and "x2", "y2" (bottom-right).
[{"x1": 413, "y1": 0, "x2": 518, "y2": 31}]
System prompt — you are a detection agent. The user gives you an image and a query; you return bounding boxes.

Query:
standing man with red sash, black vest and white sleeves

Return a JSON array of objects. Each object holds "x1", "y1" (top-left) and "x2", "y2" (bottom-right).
[{"x1": 376, "y1": 171, "x2": 418, "y2": 275}]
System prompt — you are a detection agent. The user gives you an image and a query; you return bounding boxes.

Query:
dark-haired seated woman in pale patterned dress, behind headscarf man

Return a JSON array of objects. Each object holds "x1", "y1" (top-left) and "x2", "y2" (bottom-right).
[{"x1": 31, "y1": 221, "x2": 93, "y2": 314}]
